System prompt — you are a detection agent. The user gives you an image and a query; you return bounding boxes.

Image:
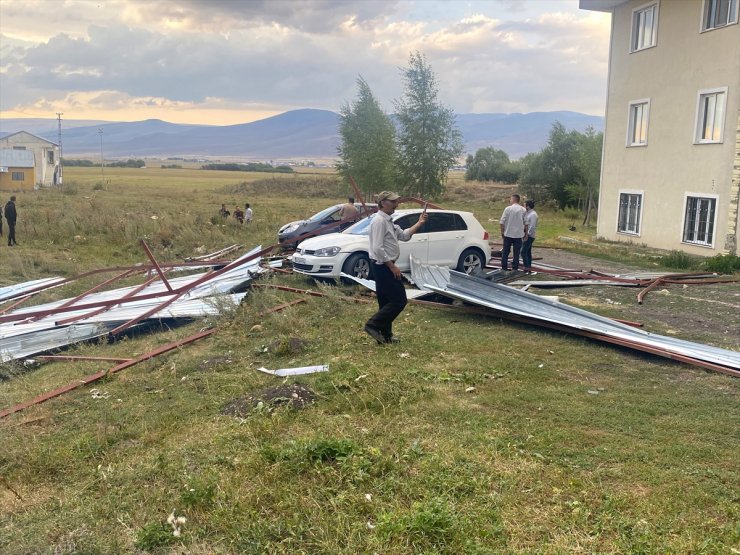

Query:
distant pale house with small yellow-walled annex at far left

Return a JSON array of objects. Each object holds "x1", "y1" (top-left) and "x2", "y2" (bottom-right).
[{"x1": 0, "y1": 131, "x2": 60, "y2": 190}]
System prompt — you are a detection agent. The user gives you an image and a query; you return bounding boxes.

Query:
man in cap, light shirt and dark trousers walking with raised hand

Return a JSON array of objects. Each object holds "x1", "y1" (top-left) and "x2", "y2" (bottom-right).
[{"x1": 365, "y1": 191, "x2": 427, "y2": 343}]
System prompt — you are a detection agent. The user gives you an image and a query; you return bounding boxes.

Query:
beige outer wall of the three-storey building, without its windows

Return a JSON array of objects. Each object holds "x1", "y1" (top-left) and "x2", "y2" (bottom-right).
[{"x1": 598, "y1": 0, "x2": 740, "y2": 256}]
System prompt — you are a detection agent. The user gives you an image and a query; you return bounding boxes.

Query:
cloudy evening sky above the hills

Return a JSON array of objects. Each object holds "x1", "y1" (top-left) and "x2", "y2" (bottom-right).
[{"x1": 0, "y1": 0, "x2": 610, "y2": 125}]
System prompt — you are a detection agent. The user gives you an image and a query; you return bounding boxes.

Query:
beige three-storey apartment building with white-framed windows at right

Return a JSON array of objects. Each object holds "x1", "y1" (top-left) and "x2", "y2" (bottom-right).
[{"x1": 580, "y1": 0, "x2": 740, "y2": 255}]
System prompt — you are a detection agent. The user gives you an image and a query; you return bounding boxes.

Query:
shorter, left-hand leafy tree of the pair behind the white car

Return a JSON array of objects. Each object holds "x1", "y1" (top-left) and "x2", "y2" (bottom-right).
[{"x1": 336, "y1": 76, "x2": 396, "y2": 192}]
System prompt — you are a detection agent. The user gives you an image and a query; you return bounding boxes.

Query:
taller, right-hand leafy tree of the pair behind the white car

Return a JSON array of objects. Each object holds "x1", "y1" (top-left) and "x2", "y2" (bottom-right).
[{"x1": 394, "y1": 52, "x2": 463, "y2": 197}]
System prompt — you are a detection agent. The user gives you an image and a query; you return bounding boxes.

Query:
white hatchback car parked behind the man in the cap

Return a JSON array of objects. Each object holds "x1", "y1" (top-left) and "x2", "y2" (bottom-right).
[{"x1": 293, "y1": 208, "x2": 491, "y2": 279}]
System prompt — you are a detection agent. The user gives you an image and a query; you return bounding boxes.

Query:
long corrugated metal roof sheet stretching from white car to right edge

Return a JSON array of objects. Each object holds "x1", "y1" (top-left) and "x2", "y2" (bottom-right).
[{"x1": 425, "y1": 271, "x2": 740, "y2": 370}]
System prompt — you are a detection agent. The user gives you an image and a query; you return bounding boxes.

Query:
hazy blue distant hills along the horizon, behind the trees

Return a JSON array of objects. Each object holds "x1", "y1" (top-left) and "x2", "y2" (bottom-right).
[{"x1": 0, "y1": 109, "x2": 604, "y2": 160}]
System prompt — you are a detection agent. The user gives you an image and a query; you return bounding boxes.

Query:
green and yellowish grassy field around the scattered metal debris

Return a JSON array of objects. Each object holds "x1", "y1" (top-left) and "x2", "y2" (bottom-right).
[{"x1": 0, "y1": 168, "x2": 740, "y2": 555}]
